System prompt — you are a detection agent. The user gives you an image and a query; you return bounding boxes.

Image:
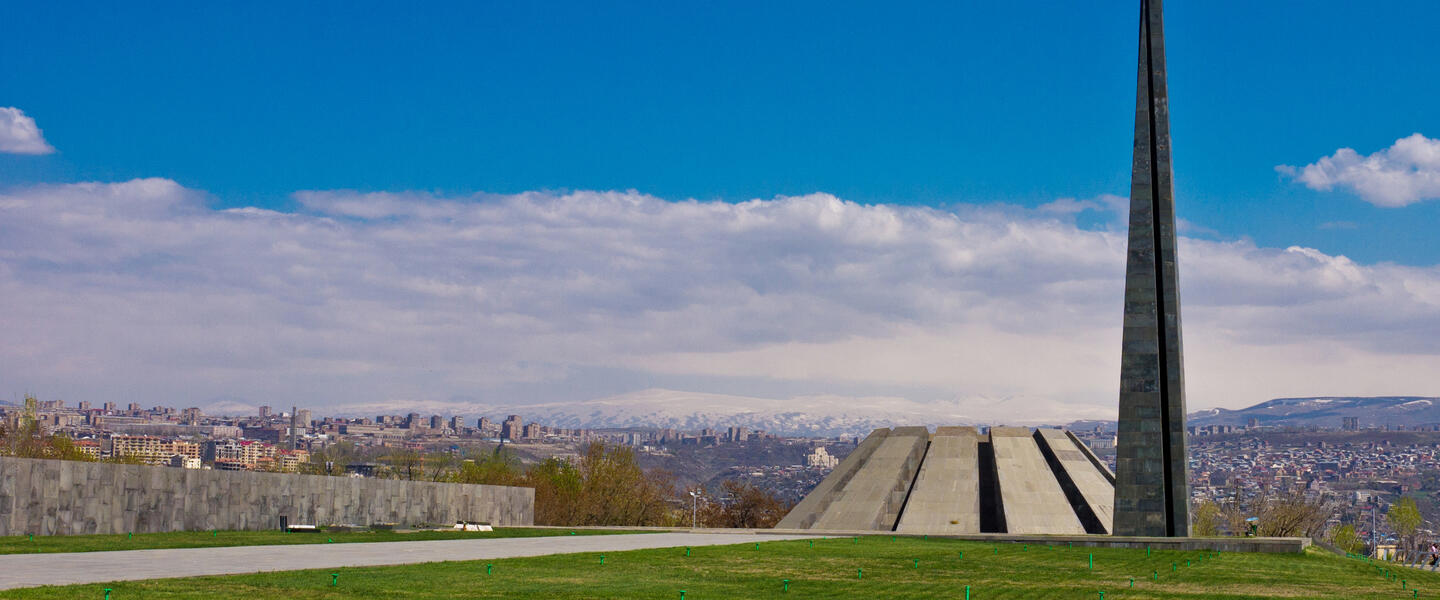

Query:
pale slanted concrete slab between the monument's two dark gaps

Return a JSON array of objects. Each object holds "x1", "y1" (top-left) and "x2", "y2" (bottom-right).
[{"x1": 991, "y1": 427, "x2": 1086, "y2": 534}]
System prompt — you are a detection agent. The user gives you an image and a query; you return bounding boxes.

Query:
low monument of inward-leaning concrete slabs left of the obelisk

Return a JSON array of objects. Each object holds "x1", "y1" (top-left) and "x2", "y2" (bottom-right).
[{"x1": 776, "y1": 427, "x2": 1115, "y2": 535}]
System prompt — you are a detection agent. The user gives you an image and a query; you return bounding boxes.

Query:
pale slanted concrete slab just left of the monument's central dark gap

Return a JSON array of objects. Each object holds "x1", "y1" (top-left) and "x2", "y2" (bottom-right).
[{"x1": 896, "y1": 427, "x2": 981, "y2": 534}]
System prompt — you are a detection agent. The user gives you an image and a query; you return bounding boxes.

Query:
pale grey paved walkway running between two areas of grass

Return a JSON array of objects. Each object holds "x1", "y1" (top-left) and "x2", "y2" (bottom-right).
[{"x1": 0, "y1": 534, "x2": 815, "y2": 590}]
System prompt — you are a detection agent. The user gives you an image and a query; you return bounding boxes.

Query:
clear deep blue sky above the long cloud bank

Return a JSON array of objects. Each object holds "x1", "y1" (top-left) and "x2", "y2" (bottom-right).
[{"x1": 8, "y1": 0, "x2": 1440, "y2": 263}]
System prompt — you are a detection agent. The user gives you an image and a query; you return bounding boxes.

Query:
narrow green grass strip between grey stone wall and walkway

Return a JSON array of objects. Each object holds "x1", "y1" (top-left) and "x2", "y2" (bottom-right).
[{"x1": 0, "y1": 527, "x2": 628, "y2": 554}]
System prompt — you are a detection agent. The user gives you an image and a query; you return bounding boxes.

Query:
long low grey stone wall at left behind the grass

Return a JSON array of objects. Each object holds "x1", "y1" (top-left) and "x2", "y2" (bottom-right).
[{"x1": 0, "y1": 458, "x2": 534, "y2": 535}]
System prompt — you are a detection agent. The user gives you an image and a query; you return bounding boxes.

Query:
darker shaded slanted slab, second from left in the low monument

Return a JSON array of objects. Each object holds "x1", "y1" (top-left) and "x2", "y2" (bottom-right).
[{"x1": 814, "y1": 427, "x2": 930, "y2": 531}]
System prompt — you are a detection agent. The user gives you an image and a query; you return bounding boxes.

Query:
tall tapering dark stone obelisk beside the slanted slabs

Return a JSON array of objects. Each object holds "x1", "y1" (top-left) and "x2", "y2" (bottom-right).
[{"x1": 1113, "y1": 0, "x2": 1189, "y2": 537}]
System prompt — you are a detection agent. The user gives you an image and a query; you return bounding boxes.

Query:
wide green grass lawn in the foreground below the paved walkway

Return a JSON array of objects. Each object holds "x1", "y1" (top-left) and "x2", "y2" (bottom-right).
[{"x1": 0, "y1": 537, "x2": 1440, "y2": 600}]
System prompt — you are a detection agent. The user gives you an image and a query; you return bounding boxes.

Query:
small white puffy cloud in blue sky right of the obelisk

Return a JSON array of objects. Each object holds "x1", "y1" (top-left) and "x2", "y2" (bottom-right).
[{"x1": 1276, "y1": 134, "x2": 1440, "y2": 207}]
